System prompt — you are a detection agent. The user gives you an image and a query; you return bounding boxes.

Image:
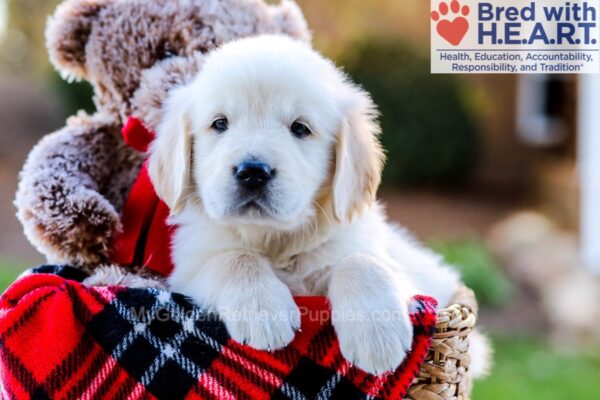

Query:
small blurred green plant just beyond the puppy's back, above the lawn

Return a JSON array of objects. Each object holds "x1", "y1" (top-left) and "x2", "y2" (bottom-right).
[{"x1": 431, "y1": 239, "x2": 514, "y2": 307}]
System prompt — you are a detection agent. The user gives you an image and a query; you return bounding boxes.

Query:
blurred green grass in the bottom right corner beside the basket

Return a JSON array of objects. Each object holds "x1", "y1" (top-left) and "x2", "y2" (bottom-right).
[{"x1": 473, "y1": 336, "x2": 600, "y2": 400}]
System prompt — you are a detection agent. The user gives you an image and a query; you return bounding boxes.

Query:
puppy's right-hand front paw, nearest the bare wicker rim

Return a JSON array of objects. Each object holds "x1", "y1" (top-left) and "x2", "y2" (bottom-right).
[{"x1": 334, "y1": 303, "x2": 413, "y2": 375}]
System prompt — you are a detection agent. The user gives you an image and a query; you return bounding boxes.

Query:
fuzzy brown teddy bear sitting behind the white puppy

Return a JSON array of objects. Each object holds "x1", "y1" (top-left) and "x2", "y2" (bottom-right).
[{"x1": 15, "y1": 0, "x2": 310, "y2": 276}]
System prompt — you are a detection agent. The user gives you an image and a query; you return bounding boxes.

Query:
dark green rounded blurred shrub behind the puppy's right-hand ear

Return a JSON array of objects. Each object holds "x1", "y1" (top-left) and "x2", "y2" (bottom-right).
[{"x1": 340, "y1": 39, "x2": 478, "y2": 185}]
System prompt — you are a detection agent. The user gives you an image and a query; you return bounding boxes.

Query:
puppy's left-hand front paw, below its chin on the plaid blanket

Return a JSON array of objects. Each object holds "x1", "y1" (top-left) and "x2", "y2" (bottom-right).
[{"x1": 219, "y1": 279, "x2": 300, "y2": 350}]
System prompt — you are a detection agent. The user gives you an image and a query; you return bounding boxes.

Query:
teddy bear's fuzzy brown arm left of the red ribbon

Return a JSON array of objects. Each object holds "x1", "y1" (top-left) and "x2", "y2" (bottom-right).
[{"x1": 15, "y1": 114, "x2": 141, "y2": 266}]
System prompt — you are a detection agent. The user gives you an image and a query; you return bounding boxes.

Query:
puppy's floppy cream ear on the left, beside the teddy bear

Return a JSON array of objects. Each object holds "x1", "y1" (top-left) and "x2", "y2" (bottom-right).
[{"x1": 148, "y1": 87, "x2": 193, "y2": 215}]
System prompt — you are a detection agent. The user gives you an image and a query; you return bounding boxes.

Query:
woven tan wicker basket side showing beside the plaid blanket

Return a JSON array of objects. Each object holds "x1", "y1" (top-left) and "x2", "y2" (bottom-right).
[{"x1": 405, "y1": 287, "x2": 477, "y2": 400}]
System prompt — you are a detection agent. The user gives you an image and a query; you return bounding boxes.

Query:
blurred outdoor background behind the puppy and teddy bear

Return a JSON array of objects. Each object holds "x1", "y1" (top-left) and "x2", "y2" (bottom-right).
[{"x1": 0, "y1": 0, "x2": 600, "y2": 400}]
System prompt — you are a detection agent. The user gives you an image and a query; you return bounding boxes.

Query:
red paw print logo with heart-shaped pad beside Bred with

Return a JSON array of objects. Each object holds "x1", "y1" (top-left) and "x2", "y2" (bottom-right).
[{"x1": 431, "y1": 0, "x2": 471, "y2": 46}]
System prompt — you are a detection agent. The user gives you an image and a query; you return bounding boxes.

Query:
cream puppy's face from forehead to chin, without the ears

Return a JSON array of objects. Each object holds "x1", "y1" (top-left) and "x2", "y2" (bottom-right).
[{"x1": 189, "y1": 60, "x2": 336, "y2": 227}]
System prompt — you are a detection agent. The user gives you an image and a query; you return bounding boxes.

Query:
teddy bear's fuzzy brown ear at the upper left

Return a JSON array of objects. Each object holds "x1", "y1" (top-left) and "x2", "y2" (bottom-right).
[{"x1": 46, "y1": 0, "x2": 112, "y2": 79}]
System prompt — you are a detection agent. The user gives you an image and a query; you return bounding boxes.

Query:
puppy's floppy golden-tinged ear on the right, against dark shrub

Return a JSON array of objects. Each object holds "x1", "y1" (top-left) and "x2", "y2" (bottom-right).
[{"x1": 332, "y1": 87, "x2": 385, "y2": 221}]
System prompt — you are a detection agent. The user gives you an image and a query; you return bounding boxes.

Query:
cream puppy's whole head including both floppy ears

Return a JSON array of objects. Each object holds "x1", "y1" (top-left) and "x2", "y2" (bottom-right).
[{"x1": 150, "y1": 36, "x2": 382, "y2": 230}]
